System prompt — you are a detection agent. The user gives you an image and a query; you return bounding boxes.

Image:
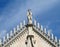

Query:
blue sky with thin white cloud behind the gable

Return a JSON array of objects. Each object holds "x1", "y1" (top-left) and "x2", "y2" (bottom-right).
[{"x1": 0, "y1": 0, "x2": 60, "y2": 38}]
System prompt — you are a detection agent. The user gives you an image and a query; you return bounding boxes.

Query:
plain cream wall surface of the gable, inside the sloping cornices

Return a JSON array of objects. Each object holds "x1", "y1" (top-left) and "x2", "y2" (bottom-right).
[{"x1": 5, "y1": 25, "x2": 53, "y2": 47}]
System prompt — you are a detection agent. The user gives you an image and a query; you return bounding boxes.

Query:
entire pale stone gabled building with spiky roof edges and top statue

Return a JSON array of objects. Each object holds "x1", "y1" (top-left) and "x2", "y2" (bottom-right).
[{"x1": 0, "y1": 9, "x2": 60, "y2": 47}]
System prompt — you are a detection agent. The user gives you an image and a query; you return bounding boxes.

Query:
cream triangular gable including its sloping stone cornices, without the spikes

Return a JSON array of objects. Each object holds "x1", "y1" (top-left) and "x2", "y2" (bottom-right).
[{"x1": 1, "y1": 25, "x2": 58, "y2": 47}]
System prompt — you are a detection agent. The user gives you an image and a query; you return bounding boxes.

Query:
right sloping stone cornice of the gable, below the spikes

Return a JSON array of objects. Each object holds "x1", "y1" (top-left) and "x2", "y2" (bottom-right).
[{"x1": 33, "y1": 26, "x2": 58, "y2": 47}]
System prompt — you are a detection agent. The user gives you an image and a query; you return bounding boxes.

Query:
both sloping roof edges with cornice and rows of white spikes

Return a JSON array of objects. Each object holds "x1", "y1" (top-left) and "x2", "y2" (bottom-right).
[{"x1": 0, "y1": 9, "x2": 60, "y2": 47}]
